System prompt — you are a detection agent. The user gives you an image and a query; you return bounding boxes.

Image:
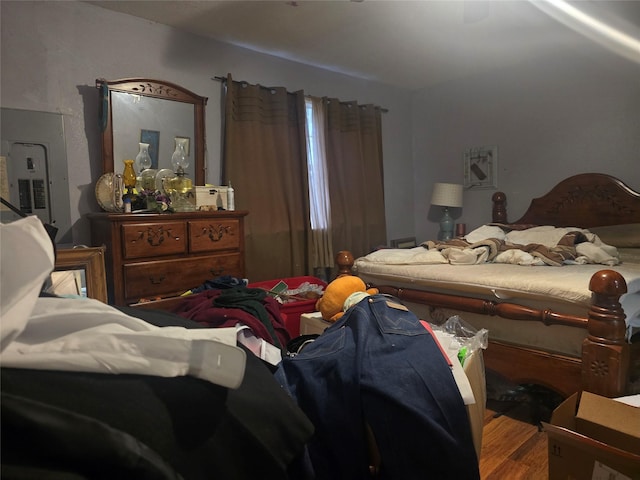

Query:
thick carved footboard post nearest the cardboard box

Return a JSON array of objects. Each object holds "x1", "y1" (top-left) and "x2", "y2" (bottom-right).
[{"x1": 582, "y1": 270, "x2": 631, "y2": 397}]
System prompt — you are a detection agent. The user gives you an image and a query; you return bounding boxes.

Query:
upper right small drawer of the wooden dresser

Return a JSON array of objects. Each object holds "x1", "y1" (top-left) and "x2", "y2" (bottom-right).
[{"x1": 189, "y1": 219, "x2": 242, "y2": 253}]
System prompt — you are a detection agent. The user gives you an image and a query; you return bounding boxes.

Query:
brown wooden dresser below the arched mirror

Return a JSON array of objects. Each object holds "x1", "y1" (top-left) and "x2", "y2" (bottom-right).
[{"x1": 88, "y1": 211, "x2": 248, "y2": 305}]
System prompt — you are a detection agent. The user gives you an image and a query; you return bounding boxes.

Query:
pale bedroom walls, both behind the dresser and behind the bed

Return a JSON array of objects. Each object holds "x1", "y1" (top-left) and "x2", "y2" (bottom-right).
[{"x1": 0, "y1": 0, "x2": 640, "y2": 251}]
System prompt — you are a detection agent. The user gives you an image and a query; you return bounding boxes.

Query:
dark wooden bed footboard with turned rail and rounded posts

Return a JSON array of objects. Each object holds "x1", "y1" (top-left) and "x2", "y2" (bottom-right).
[{"x1": 336, "y1": 250, "x2": 640, "y2": 397}]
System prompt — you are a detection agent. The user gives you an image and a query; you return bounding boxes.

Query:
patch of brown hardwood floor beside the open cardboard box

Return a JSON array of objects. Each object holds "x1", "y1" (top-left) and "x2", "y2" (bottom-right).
[{"x1": 480, "y1": 403, "x2": 549, "y2": 480}]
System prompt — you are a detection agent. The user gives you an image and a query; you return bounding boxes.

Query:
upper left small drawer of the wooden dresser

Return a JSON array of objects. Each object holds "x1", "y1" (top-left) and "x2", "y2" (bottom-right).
[{"x1": 122, "y1": 222, "x2": 187, "y2": 259}]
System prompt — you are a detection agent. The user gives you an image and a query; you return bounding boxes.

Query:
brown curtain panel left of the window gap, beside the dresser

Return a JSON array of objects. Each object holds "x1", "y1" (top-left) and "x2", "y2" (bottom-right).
[{"x1": 222, "y1": 75, "x2": 311, "y2": 282}]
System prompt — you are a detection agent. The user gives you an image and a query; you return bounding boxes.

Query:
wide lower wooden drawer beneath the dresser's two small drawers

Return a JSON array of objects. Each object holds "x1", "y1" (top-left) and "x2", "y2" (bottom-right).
[{"x1": 123, "y1": 253, "x2": 243, "y2": 301}]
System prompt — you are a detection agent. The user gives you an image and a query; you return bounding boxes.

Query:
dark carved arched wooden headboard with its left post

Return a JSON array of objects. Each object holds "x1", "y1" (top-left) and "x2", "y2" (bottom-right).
[{"x1": 493, "y1": 173, "x2": 640, "y2": 228}]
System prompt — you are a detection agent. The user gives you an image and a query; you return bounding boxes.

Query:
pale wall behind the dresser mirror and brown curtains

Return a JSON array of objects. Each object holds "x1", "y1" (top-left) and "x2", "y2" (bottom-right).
[{"x1": 0, "y1": 0, "x2": 414, "y2": 244}]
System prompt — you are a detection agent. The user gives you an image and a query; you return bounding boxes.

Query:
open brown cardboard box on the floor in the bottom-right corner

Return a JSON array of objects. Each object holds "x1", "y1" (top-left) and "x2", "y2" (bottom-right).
[{"x1": 543, "y1": 392, "x2": 640, "y2": 480}]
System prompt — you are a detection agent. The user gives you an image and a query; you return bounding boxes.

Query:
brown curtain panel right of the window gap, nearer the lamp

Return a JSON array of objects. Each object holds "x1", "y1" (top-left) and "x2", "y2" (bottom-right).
[{"x1": 323, "y1": 98, "x2": 387, "y2": 258}]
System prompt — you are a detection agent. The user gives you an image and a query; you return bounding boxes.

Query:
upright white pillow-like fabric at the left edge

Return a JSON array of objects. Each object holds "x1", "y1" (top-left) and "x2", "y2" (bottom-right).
[{"x1": 0, "y1": 216, "x2": 55, "y2": 352}]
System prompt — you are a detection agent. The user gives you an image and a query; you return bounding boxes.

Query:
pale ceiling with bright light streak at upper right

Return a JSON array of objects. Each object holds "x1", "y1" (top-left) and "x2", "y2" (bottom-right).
[{"x1": 88, "y1": 0, "x2": 640, "y2": 90}]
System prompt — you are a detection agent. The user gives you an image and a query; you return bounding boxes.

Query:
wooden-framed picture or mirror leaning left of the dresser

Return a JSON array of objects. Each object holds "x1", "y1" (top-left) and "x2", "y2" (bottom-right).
[{"x1": 47, "y1": 247, "x2": 107, "y2": 303}]
